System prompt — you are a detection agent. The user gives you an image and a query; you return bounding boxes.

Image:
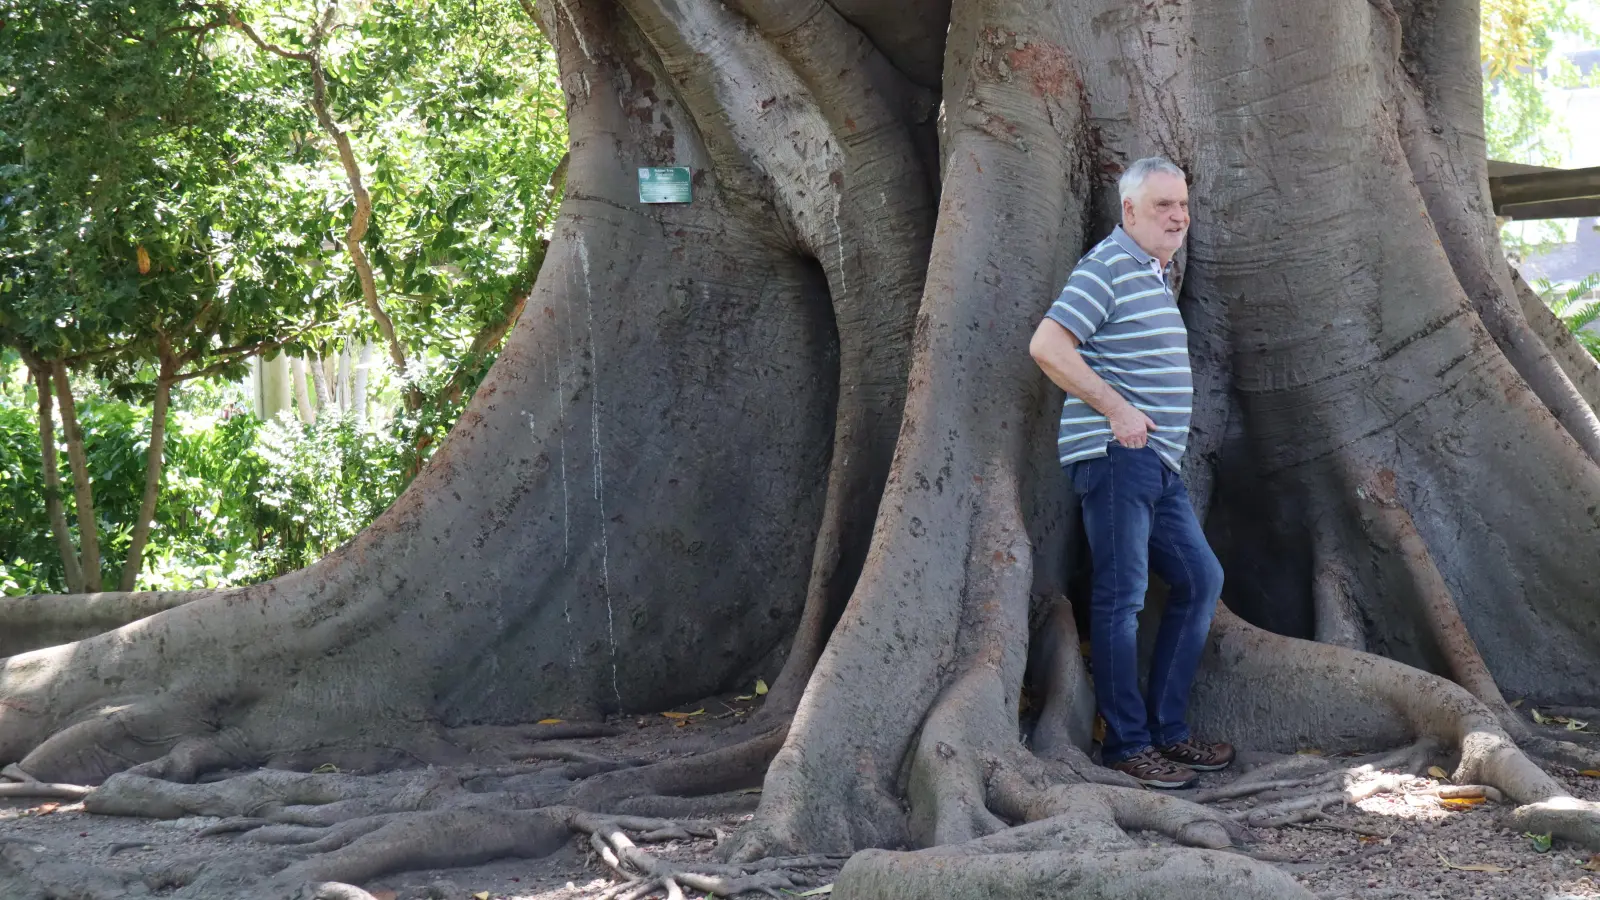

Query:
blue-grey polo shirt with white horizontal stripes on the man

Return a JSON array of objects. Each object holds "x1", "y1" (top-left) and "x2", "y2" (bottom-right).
[{"x1": 1046, "y1": 226, "x2": 1194, "y2": 471}]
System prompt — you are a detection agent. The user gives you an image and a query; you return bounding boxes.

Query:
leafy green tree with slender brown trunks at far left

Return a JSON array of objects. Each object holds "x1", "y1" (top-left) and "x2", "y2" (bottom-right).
[{"x1": 0, "y1": 2, "x2": 340, "y2": 591}]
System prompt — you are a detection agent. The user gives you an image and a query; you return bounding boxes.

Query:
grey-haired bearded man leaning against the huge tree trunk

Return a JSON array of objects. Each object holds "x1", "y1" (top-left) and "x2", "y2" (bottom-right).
[{"x1": 1029, "y1": 157, "x2": 1234, "y2": 788}]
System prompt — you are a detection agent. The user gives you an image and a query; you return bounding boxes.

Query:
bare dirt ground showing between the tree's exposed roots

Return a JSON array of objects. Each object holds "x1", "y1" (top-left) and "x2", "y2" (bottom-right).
[{"x1": 9, "y1": 697, "x2": 1600, "y2": 900}]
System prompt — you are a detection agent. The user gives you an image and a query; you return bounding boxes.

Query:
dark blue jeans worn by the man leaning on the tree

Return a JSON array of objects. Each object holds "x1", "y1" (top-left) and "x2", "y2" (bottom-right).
[{"x1": 1067, "y1": 442, "x2": 1222, "y2": 755}]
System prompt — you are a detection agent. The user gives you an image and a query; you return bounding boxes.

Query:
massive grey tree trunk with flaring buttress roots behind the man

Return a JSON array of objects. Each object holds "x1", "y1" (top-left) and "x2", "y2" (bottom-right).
[{"x1": 0, "y1": 0, "x2": 1600, "y2": 898}]
